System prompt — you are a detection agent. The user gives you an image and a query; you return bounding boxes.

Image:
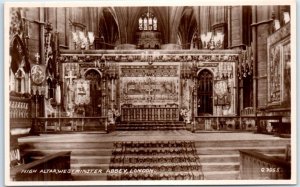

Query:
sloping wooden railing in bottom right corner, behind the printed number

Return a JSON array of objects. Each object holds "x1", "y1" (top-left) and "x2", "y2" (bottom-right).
[{"x1": 240, "y1": 150, "x2": 291, "y2": 180}]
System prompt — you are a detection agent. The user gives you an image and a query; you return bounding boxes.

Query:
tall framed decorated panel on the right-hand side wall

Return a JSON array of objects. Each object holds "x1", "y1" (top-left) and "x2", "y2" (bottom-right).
[{"x1": 267, "y1": 24, "x2": 291, "y2": 106}]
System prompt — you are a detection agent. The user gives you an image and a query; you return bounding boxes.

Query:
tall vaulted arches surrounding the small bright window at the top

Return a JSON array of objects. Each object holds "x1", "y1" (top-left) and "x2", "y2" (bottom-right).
[{"x1": 99, "y1": 7, "x2": 199, "y2": 44}]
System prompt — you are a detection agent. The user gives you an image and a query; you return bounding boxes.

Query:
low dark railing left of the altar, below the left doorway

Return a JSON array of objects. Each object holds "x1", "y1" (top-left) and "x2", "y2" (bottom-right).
[{"x1": 35, "y1": 117, "x2": 107, "y2": 132}]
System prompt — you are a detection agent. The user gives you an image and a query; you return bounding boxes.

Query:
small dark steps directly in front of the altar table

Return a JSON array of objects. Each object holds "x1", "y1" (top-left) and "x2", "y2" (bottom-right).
[{"x1": 116, "y1": 121, "x2": 187, "y2": 131}]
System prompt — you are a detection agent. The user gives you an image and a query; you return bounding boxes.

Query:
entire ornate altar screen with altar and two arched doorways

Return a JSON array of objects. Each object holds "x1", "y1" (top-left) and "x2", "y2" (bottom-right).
[{"x1": 45, "y1": 50, "x2": 244, "y2": 130}]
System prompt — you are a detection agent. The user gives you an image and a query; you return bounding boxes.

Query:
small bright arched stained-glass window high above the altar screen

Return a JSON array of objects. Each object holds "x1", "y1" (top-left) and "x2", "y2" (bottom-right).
[{"x1": 138, "y1": 12, "x2": 158, "y2": 31}]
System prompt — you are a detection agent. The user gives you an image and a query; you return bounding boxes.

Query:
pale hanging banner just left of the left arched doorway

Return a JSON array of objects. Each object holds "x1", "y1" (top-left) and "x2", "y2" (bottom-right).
[{"x1": 74, "y1": 79, "x2": 90, "y2": 105}]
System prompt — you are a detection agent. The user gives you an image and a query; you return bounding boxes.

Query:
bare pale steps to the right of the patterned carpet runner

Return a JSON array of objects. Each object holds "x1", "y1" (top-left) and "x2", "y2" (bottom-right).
[{"x1": 196, "y1": 139, "x2": 289, "y2": 180}]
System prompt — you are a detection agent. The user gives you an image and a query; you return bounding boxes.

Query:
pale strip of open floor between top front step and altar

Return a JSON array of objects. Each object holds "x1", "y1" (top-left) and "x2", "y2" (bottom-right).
[{"x1": 19, "y1": 130, "x2": 288, "y2": 142}]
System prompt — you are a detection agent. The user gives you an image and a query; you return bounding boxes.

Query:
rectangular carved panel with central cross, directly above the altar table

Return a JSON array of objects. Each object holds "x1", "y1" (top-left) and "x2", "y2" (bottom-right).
[{"x1": 120, "y1": 65, "x2": 179, "y2": 105}]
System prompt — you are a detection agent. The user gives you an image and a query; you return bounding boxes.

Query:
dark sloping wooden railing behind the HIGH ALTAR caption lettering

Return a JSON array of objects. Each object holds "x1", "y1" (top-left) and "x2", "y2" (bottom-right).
[{"x1": 10, "y1": 151, "x2": 72, "y2": 181}]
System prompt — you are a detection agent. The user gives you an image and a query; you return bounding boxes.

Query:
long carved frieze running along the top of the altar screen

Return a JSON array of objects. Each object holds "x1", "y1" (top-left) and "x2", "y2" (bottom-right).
[{"x1": 59, "y1": 50, "x2": 240, "y2": 63}]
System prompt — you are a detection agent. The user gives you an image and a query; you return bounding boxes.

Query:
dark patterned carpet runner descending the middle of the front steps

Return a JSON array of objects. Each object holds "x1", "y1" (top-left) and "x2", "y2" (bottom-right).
[{"x1": 107, "y1": 141, "x2": 204, "y2": 180}]
